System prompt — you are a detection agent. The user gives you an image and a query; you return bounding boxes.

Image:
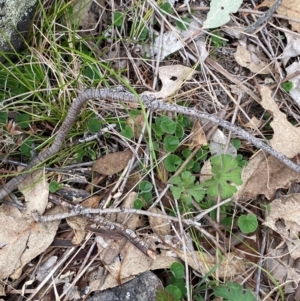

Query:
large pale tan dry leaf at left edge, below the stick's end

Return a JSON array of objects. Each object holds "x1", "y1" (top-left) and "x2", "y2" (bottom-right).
[{"x1": 0, "y1": 171, "x2": 60, "y2": 279}]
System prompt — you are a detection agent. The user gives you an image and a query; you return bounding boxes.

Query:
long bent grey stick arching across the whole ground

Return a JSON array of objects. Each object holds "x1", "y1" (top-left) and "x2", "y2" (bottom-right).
[{"x1": 0, "y1": 87, "x2": 300, "y2": 209}]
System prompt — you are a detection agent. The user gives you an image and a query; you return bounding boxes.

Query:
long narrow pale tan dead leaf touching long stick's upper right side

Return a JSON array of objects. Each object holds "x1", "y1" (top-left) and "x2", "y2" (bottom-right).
[{"x1": 261, "y1": 86, "x2": 300, "y2": 158}]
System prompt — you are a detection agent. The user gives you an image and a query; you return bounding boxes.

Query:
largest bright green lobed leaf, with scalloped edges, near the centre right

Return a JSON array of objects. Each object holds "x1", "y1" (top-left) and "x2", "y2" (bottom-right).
[{"x1": 205, "y1": 154, "x2": 243, "y2": 199}]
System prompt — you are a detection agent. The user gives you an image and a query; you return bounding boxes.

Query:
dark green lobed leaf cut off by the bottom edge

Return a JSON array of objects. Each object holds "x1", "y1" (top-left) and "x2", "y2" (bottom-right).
[{"x1": 214, "y1": 281, "x2": 256, "y2": 301}]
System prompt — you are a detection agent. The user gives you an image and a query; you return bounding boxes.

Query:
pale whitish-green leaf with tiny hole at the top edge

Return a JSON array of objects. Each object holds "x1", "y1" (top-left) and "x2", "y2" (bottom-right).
[{"x1": 203, "y1": 0, "x2": 243, "y2": 29}]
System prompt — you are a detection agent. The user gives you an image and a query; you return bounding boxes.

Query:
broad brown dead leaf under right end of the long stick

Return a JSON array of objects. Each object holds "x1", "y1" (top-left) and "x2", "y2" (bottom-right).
[{"x1": 235, "y1": 153, "x2": 300, "y2": 201}]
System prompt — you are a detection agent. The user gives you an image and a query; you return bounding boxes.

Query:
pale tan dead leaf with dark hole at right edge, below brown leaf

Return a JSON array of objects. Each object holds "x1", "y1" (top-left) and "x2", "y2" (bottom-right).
[{"x1": 263, "y1": 193, "x2": 300, "y2": 259}]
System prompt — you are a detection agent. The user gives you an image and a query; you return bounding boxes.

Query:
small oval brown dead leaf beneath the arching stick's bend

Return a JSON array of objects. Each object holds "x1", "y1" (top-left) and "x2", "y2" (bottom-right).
[{"x1": 92, "y1": 149, "x2": 132, "y2": 176}]
